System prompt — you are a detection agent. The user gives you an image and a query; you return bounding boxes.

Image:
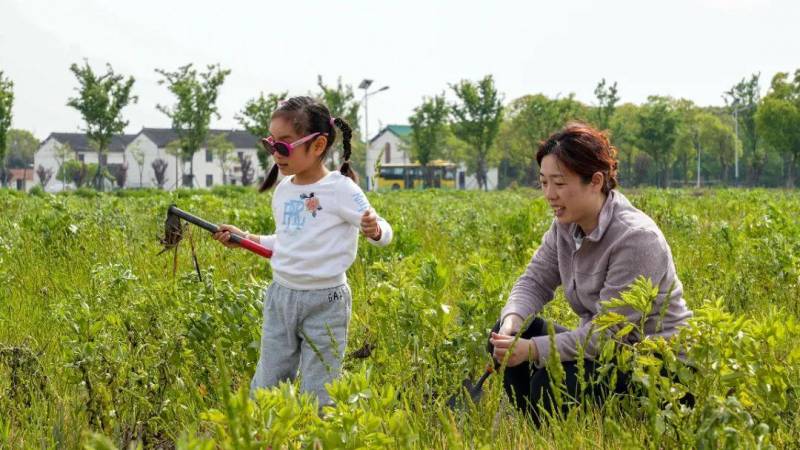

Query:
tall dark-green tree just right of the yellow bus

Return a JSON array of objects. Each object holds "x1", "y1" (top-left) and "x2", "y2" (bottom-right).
[{"x1": 450, "y1": 75, "x2": 503, "y2": 190}]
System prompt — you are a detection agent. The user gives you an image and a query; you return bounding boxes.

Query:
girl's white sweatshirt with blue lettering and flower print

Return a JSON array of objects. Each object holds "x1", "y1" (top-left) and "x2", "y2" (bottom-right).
[{"x1": 260, "y1": 171, "x2": 392, "y2": 290}]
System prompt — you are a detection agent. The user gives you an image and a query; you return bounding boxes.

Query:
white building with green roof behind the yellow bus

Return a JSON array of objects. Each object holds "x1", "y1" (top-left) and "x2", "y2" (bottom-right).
[{"x1": 365, "y1": 125, "x2": 497, "y2": 190}]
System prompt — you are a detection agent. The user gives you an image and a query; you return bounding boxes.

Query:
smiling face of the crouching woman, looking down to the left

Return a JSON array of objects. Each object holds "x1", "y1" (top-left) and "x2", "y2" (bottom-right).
[{"x1": 539, "y1": 155, "x2": 603, "y2": 231}]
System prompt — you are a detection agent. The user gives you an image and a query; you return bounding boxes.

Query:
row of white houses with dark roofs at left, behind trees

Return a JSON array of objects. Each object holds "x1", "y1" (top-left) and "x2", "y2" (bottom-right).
[{"x1": 34, "y1": 128, "x2": 264, "y2": 191}]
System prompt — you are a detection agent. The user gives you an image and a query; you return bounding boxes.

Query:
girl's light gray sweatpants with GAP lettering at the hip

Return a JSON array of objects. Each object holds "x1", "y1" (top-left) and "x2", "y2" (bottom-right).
[{"x1": 250, "y1": 282, "x2": 352, "y2": 405}]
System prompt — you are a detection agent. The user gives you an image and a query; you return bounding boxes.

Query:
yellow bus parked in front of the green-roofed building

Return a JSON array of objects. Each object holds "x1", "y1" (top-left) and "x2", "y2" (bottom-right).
[{"x1": 375, "y1": 159, "x2": 458, "y2": 190}]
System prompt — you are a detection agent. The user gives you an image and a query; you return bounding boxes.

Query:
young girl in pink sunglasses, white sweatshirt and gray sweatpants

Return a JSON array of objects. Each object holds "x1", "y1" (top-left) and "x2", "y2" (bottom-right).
[{"x1": 214, "y1": 97, "x2": 392, "y2": 405}]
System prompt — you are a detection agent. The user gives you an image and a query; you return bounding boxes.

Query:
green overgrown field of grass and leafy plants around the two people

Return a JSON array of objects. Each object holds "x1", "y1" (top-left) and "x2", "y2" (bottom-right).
[{"x1": 0, "y1": 189, "x2": 800, "y2": 448}]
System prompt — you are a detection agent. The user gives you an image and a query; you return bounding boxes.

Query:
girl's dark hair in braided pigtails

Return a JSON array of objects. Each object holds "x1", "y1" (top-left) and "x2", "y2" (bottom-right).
[{"x1": 258, "y1": 97, "x2": 358, "y2": 192}]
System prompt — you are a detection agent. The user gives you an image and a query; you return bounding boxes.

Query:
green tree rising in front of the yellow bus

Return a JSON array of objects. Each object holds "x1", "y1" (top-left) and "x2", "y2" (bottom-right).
[{"x1": 408, "y1": 93, "x2": 448, "y2": 187}]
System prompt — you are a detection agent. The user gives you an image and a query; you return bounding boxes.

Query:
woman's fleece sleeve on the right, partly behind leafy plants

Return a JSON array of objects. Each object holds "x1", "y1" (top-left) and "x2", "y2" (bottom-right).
[{"x1": 532, "y1": 229, "x2": 671, "y2": 367}]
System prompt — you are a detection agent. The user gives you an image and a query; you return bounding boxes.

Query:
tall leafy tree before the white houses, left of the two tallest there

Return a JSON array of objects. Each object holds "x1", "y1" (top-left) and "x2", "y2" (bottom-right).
[{"x1": 67, "y1": 61, "x2": 138, "y2": 190}]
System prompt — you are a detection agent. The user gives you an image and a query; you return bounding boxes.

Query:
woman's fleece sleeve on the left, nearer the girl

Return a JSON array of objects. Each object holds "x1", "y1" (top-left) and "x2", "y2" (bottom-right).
[{"x1": 500, "y1": 221, "x2": 561, "y2": 322}]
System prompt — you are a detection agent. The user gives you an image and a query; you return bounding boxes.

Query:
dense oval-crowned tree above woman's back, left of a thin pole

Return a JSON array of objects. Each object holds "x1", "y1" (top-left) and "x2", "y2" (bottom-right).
[{"x1": 637, "y1": 95, "x2": 679, "y2": 187}]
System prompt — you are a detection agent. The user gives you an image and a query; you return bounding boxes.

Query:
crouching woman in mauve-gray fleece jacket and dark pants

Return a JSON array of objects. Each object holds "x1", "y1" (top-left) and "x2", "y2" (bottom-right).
[{"x1": 489, "y1": 124, "x2": 692, "y2": 423}]
